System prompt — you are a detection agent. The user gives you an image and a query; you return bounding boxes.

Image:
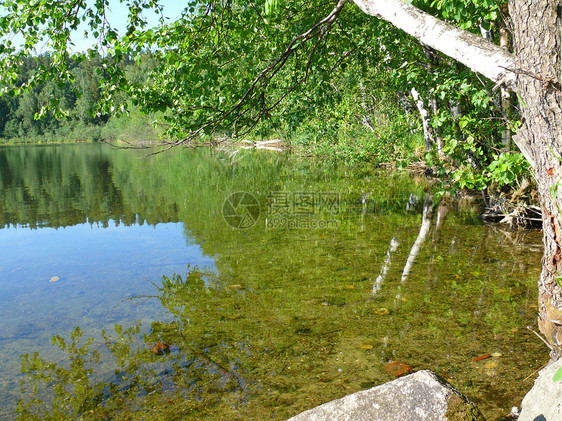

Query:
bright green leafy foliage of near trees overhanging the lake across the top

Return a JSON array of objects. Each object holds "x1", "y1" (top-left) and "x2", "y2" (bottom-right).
[{"x1": 0, "y1": 0, "x2": 526, "y2": 189}]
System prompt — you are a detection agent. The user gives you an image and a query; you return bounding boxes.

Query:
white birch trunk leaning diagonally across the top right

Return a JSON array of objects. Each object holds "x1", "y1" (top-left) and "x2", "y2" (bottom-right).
[{"x1": 354, "y1": 0, "x2": 515, "y2": 86}]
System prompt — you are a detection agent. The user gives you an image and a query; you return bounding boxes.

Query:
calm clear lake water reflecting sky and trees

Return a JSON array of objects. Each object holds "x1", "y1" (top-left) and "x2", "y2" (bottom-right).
[{"x1": 0, "y1": 144, "x2": 548, "y2": 420}]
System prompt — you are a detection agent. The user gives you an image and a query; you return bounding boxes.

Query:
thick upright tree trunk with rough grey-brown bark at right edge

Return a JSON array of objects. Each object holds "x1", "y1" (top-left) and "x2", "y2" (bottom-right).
[{"x1": 509, "y1": 0, "x2": 562, "y2": 357}]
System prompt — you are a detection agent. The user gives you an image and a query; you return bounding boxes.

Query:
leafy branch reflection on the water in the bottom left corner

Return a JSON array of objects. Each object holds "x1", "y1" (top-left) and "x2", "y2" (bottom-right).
[{"x1": 17, "y1": 324, "x2": 170, "y2": 420}]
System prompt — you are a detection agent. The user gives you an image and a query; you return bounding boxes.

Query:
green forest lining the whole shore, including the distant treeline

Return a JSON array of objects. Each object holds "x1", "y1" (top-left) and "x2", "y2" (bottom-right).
[{"x1": 0, "y1": 2, "x2": 531, "y2": 194}]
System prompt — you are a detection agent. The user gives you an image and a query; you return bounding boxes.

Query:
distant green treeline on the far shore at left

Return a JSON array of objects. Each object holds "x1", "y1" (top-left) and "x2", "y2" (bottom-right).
[{"x1": 0, "y1": 54, "x2": 161, "y2": 144}]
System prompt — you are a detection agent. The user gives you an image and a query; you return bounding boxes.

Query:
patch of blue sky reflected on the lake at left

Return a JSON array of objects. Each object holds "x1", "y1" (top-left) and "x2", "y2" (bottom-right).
[{"x1": 0, "y1": 221, "x2": 214, "y2": 414}]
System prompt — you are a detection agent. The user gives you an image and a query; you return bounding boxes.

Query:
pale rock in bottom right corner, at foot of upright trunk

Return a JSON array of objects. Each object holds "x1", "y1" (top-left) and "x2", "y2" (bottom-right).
[{"x1": 518, "y1": 360, "x2": 562, "y2": 421}]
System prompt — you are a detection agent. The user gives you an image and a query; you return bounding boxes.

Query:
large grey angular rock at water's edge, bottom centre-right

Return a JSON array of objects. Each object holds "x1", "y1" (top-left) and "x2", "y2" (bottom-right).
[{"x1": 289, "y1": 370, "x2": 484, "y2": 421}]
